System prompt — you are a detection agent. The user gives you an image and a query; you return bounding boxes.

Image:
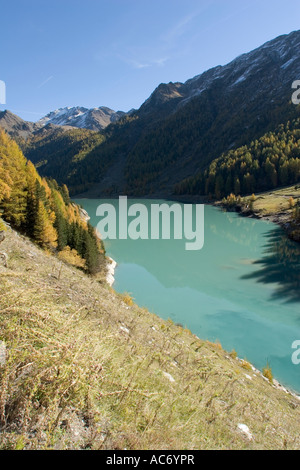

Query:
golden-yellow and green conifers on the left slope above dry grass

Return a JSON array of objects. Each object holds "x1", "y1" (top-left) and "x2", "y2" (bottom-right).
[{"x1": 0, "y1": 130, "x2": 104, "y2": 274}]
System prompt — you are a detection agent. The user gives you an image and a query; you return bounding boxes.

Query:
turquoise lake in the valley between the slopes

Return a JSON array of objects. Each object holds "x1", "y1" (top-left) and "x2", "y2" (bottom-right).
[{"x1": 75, "y1": 199, "x2": 300, "y2": 393}]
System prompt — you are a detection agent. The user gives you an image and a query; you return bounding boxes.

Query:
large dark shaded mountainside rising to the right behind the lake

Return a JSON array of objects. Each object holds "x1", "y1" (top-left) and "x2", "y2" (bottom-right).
[{"x1": 17, "y1": 31, "x2": 300, "y2": 196}]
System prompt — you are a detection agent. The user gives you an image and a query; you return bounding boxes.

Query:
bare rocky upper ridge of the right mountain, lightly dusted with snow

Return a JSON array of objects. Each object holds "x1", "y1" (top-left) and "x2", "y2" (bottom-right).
[{"x1": 139, "y1": 31, "x2": 300, "y2": 118}]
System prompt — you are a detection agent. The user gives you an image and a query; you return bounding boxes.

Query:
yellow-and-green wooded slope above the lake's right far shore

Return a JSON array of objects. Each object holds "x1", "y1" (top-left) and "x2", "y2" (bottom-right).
[{"x1": 175, "y1": 118, "x2": 300, "y2": 199}]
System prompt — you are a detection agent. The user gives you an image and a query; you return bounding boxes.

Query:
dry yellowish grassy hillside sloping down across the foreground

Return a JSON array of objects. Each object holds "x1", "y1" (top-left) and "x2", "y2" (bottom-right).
[{"x1": 0, "y1": 229, "x2": 300, "y2": 449}]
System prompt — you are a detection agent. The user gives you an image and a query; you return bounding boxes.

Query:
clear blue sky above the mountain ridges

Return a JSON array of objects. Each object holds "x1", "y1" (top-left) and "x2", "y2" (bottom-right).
[{"x1": 0, "y1": 0, "x2": 300, "y2": 121}]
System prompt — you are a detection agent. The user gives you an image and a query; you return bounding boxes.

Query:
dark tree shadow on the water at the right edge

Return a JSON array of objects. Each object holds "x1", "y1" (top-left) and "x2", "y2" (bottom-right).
[{"x1": 242, "y1": 228, "x2": 300, "y2": 302}]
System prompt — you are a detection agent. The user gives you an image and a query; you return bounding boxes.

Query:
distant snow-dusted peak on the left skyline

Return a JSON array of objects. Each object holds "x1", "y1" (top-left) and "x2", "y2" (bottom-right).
[{"x1": 38, "y1": 106, "x2": 125, "y2": 131}]
